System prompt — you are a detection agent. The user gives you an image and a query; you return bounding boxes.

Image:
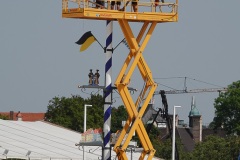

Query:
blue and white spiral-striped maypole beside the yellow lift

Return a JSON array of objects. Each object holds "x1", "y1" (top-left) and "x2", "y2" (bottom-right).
[{"x1": 103, "y1": 21, "x2": 113, "y2": 160}]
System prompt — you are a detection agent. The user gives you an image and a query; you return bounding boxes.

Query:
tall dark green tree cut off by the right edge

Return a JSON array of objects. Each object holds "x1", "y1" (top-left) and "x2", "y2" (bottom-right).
[{"x1": 214, "y1": 81, "x2": 240, "y2": 135}]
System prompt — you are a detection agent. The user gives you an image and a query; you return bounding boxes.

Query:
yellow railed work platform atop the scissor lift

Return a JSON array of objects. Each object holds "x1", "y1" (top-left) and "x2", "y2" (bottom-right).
[{"x1": 62, "y1": 0, "x2": 178, "y2": 23}]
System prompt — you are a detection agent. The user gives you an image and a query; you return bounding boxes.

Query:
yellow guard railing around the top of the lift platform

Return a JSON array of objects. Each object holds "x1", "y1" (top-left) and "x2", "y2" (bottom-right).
[{"x1": 62, "y1": 0, "x2": 178, "y2": 14}]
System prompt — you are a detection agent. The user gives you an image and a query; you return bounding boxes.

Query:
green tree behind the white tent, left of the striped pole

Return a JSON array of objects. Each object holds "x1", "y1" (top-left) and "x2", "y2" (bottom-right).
[{"x1": 45, "y1": 95, "x2": 103, "y2": 132}]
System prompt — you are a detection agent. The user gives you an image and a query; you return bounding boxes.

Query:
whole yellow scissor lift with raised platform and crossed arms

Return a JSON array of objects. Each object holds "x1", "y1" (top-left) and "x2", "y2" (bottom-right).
[{"x1": 62, "y1": 0, "x2": 178, "y2": 160}]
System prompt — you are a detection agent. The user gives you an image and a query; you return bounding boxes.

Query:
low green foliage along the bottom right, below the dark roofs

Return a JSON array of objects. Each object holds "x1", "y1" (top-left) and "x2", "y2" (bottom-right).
[{"x1": 153, "y1": 135, "x2": 240, "y2": 160}]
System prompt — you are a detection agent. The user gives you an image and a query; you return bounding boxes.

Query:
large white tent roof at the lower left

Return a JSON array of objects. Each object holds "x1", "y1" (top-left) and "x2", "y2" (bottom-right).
[{"x1": 0, "y1": 119, "x2": 162, "y2": 160}]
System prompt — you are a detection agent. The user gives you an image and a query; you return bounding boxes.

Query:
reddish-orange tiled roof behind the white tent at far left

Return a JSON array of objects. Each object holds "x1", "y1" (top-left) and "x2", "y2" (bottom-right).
[{"x1": 0, "y1": 112, "x2": 45, "y2": 122}]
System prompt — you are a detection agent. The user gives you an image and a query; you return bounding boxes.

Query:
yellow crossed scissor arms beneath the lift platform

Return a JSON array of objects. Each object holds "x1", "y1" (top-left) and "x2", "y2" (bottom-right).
[{"x1": 114, "y1": 19, "x2": 157, "y2": 160}]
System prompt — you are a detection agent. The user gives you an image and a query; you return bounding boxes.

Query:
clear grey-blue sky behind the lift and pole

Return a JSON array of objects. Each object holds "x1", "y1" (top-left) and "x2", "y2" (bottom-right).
[{"x1": 0, "y1": 0, "x2": 240, "y2": 123}]
